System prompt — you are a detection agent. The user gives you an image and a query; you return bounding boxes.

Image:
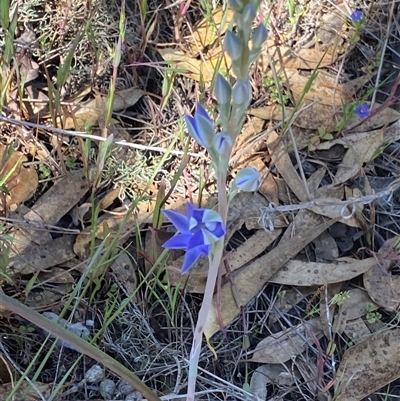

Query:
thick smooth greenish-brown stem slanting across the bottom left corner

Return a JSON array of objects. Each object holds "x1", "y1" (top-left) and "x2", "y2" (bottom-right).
[{"x1": 0, "y1": 293, "x2": 161, "y2": 401}]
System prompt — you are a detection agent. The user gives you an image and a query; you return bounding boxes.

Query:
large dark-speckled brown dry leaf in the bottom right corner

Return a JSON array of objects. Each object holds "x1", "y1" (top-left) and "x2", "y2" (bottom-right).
[{"x1": 335, "y1": 329, "x2": 400, "y2": 401}]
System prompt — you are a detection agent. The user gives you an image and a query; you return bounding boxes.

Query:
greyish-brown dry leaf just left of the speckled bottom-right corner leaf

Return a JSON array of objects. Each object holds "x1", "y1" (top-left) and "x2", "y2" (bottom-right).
[{"x1": 250, "y1": 318, "x2": 324, "y2": 363}]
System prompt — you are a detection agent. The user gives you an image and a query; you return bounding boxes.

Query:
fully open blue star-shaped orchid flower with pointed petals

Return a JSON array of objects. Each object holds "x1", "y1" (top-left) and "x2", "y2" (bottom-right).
[{"x1": 162, "y1": 203, "x2": 226, "y2": 274}]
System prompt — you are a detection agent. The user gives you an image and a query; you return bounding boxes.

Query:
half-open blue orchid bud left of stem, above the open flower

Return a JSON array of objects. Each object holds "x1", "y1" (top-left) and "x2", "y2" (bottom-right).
[{"x1": 185, "y1": 103, "x2": 215, "y2": 149}]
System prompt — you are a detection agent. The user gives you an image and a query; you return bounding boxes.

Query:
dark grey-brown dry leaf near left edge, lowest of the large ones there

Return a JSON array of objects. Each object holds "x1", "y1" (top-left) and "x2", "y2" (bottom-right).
[{"x1": 6, "y1": 235, "x2": 75, "y2": 277}]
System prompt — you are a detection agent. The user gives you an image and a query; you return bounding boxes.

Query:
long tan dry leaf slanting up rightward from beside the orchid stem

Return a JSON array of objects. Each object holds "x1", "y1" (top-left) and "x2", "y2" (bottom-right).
[{"x1": 204, "y1": 216, "x2": 337, "y2": 338}]
